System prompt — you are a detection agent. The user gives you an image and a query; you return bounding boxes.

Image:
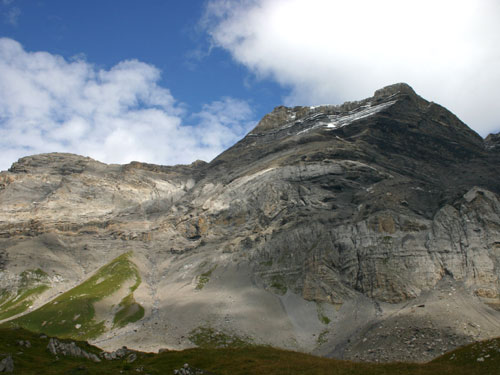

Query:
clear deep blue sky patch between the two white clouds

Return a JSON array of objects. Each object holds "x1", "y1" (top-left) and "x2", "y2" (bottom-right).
[{"x1": 0, "y1": 0, "x2": 281, "y2": 113}]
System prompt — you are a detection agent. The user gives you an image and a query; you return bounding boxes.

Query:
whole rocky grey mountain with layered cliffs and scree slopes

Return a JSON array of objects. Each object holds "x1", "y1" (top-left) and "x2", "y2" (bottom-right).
[{"x1": 0, "y1": 84, "x2": 500, "y2": 361}]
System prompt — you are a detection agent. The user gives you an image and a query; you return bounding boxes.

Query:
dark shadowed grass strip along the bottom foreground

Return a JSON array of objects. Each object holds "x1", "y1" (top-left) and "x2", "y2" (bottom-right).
[{"x1": 0, "y1": 328, "x2": 500, "y2": 375}]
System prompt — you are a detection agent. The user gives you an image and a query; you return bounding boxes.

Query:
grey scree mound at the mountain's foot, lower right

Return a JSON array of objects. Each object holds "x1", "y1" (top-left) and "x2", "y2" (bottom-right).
[{"x1": 322, "y1": 279, "x2": 498, "y2": 362}]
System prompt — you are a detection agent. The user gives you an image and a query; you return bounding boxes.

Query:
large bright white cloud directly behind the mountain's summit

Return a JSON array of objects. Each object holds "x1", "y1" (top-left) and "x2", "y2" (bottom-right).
[{"x1": 202, "y1": 0, "x2": 500, "y2": 136}]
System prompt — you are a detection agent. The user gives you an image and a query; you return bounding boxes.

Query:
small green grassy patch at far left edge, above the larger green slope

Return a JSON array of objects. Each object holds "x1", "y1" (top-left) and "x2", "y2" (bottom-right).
[{"x1": 0, "y1": 269, "x2": 49, "y2": 320}]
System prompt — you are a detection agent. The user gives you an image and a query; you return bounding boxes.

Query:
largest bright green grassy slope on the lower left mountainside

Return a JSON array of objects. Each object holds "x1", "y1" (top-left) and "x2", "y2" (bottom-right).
[{"x1": 4, "y1": 253, "x2": 144, "y2": 340}]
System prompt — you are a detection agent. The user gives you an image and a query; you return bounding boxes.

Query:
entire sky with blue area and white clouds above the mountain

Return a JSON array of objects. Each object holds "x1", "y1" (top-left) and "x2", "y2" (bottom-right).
[{"x1": 0, "y1": 0, "x2": 500, "y2": 170}]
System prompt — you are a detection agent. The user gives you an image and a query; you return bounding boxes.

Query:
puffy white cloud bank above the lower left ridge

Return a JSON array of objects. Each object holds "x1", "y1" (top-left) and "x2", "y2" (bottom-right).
[{"x1": 0, "y1": 38, "x2": 254, "y2": 170}]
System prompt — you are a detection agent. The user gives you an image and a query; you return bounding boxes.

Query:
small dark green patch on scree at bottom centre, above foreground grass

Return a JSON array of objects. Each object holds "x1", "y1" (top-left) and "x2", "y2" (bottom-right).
[{"x1": 188, "y1": 327, "x2": 252, "y2": 348}]
